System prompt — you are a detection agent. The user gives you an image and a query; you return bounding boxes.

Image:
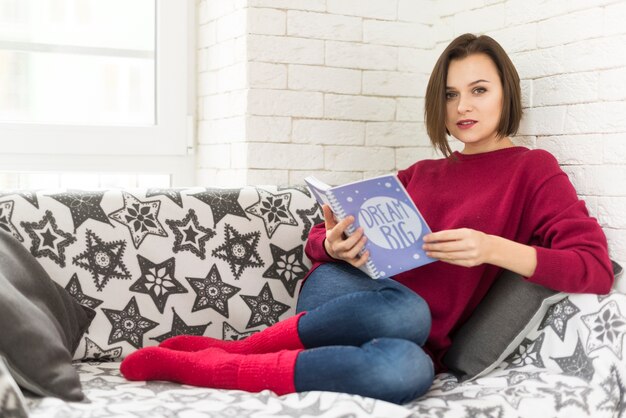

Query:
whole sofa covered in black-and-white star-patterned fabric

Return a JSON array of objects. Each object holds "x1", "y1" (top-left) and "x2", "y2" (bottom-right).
[{"x1": 0, "y1": 186, "x2": 626, "y2": 418}]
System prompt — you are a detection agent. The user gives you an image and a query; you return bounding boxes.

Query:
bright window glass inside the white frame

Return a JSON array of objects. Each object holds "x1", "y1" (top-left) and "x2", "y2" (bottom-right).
[{"x1": 0, "y1": 0, "x2": 156, "y2": 126}]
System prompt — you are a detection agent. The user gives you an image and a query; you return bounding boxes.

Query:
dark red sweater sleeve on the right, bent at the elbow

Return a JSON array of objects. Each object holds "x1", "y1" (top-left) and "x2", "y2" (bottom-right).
[{"x1": 526, "y1": 170, "x2": 613, "y2": 294}]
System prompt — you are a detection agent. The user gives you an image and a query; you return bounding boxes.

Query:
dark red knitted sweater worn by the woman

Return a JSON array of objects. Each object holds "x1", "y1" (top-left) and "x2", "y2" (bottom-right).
[{"x1": 305, "y1": 147, "x2": 613, "y2": 372}]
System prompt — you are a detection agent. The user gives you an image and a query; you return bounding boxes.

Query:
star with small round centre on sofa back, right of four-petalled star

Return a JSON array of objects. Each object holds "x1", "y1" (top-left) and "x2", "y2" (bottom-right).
[{"x1": 186, "y1": 264, "x2": 241, "y2": 318}]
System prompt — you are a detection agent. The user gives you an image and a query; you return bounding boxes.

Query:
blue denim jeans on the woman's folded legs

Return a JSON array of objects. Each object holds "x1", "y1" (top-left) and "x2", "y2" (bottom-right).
[{"x1": 295, "y1": 262, "x2": 434, "y2": 404}]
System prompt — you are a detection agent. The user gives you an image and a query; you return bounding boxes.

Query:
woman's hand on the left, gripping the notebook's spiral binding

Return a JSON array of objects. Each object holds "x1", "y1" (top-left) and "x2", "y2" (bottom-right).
[{"x1": 322, "y1": 205, "x2": 369, "y2": 267}]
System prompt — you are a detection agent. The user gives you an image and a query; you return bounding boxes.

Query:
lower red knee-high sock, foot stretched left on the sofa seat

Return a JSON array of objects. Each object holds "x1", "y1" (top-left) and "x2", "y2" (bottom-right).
[{"x1": 120, "y1": 347, "x2": 302, "y2": 395}]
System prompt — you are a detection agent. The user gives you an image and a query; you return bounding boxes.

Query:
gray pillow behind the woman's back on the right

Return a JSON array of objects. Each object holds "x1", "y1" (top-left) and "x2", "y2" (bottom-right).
[{"x1": 443, "y1": 261, "x2": 622, "y2": 381}]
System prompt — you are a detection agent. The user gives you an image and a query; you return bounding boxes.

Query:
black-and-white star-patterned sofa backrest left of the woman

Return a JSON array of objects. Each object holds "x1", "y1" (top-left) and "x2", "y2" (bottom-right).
[{"x1": 0, "y1": 186, "x2": 323, "y2": 360}]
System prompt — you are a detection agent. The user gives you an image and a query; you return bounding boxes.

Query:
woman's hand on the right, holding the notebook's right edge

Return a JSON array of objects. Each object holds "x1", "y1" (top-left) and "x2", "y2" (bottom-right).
[{"x1": 422, "y1": 228, "x2": 494, "y2": 267}]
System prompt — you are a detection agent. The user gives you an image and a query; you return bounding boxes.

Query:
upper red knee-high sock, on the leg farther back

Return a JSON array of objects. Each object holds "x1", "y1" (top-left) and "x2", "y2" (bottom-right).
[{"x1": 159, "y1": 312, "x2": 306, "y2": 354}]
